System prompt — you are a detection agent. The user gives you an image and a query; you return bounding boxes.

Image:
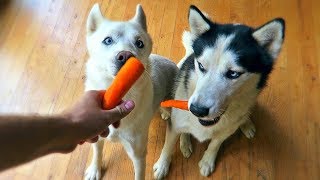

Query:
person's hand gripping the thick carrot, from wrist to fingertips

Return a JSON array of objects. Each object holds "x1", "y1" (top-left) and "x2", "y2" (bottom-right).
[{"x1": 63, "y1": 91, "x2": 135, "y2": 150}]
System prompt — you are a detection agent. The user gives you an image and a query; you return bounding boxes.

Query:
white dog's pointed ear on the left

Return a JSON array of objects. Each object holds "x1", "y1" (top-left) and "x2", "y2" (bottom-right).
[{"x1": 87, "y1": 3, "x2": 104, "y2": 34}]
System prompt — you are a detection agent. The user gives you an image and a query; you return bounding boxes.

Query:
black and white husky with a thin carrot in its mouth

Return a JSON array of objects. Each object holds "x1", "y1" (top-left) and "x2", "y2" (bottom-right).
[{"x1": 153, "y1": 6, "x2": 285, "y2": 179}]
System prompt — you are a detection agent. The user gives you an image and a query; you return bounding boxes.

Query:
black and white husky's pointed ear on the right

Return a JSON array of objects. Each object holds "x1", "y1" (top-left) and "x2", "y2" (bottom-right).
[{"x1": 252, "y1": 18, "x2": 285, "y2": 58}]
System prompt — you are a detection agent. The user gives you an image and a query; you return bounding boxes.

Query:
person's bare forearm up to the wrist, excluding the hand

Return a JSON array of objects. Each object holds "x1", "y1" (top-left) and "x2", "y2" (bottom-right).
[{"x1": 0, "y1": 115, "x2": 76, "y2": 170}]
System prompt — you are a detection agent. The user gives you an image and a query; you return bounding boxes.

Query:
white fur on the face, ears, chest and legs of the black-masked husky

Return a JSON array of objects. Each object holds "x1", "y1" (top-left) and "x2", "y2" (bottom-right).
[{"x1": 153, "y1": 9, "x2": 283, "y2": 179}]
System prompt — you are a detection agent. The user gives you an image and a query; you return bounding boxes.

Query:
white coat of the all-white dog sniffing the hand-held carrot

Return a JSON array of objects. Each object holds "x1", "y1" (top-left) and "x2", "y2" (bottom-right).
[{"x1": 85, "y1": 4, "x2": 177, "y2": 180}]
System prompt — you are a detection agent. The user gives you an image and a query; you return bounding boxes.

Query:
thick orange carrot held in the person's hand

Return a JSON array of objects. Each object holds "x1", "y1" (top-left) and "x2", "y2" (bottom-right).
[{"x1": 102, "y1": 57, "x2": 144, "y2": 128}]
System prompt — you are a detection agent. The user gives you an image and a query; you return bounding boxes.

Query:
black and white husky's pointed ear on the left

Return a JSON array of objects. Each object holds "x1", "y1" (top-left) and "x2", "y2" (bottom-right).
[{"x1": 188, "y1": 5, "x2": 210, "y2": 35}]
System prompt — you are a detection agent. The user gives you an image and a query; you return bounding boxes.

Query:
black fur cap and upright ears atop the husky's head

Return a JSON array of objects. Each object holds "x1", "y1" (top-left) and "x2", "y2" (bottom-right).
[{"x1": 188, "y1": 5, "x2": 285, "y2": 88}]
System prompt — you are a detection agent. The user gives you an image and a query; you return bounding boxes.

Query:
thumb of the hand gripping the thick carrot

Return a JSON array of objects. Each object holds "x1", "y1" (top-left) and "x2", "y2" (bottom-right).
[{"x1": 104, "y1": 101, "x2": 135, "y2": 124}]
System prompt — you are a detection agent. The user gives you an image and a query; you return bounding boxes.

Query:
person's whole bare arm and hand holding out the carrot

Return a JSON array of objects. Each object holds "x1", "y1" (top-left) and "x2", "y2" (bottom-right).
[{"x1": 0, "y1": 91, "x2": 134, "y2": 171}]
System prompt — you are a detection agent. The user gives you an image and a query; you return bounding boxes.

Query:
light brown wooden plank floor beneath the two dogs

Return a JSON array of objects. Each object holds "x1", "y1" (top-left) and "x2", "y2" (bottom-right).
[{"x1": 0, "y1": 0, "x2": 320, "y2": 180}]
